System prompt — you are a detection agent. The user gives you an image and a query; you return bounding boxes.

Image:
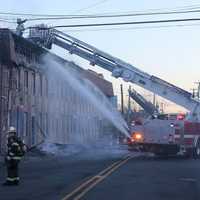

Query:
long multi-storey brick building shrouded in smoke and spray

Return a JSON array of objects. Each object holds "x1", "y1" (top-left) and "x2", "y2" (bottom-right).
[{"x1": 0, "y1": 29, "x2": 113, "y2": 150}]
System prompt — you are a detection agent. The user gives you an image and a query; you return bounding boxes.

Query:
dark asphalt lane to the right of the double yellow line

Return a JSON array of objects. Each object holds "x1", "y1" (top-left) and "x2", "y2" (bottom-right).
[{"x1": 82, "y1": 156, "x2": 200, "y2": 200}]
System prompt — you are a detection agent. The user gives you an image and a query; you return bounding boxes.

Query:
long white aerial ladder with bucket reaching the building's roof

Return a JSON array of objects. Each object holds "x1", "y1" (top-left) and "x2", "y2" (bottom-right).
[{"x1": 29, "y1": 25, "x2": 200, "y2": 121}]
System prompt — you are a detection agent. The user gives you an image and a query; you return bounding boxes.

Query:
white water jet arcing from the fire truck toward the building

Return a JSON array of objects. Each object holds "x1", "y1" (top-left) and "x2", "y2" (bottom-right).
[{"x1": 43, "y1": 56, "x2": 129, "y2": 145}]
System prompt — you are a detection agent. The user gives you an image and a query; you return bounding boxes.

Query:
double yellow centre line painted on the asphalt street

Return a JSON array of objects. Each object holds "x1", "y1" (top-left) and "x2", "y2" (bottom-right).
[{"x1": 62, "y1": 155, "x2": 133, "y2": 200}]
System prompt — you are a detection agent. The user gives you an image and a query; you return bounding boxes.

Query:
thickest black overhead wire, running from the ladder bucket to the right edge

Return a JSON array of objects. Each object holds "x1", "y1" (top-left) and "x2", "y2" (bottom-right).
[{"x1": 28, "y1": 18, "x2": 200, "y2": 29}]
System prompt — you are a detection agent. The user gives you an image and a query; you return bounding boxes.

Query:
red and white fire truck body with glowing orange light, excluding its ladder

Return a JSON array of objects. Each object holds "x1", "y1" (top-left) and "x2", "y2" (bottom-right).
[{"x1": 128, "y1": 114, "x2": 200, "y2": 158}]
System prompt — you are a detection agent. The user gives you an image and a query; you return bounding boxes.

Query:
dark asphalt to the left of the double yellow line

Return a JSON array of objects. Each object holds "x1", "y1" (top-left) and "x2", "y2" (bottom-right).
[{"x1": 0, "y1": 145, "x2": 127, "y2": 200}]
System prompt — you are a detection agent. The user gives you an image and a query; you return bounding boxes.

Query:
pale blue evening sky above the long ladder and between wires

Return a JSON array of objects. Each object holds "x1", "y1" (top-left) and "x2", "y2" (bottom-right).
[{"x1": 0, "y1": 0, "x2": 200, "y2": 112}]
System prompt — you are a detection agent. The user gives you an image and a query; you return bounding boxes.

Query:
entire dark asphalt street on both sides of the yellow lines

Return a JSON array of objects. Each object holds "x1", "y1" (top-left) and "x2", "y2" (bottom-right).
[{"x1": 0, "y1": 146, "x2": 200, "y2": 200}]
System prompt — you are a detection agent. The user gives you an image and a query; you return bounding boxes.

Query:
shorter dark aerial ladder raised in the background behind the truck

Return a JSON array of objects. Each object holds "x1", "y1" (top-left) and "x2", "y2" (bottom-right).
[{"x1": 128, "y1": 88, "x2": 159, "y2": 116}]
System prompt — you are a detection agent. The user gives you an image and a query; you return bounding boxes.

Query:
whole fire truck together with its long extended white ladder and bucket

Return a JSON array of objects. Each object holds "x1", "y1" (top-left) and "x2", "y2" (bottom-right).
[{"x1": 29, "y1": 25, "x2": 200, "y2": 157}]
